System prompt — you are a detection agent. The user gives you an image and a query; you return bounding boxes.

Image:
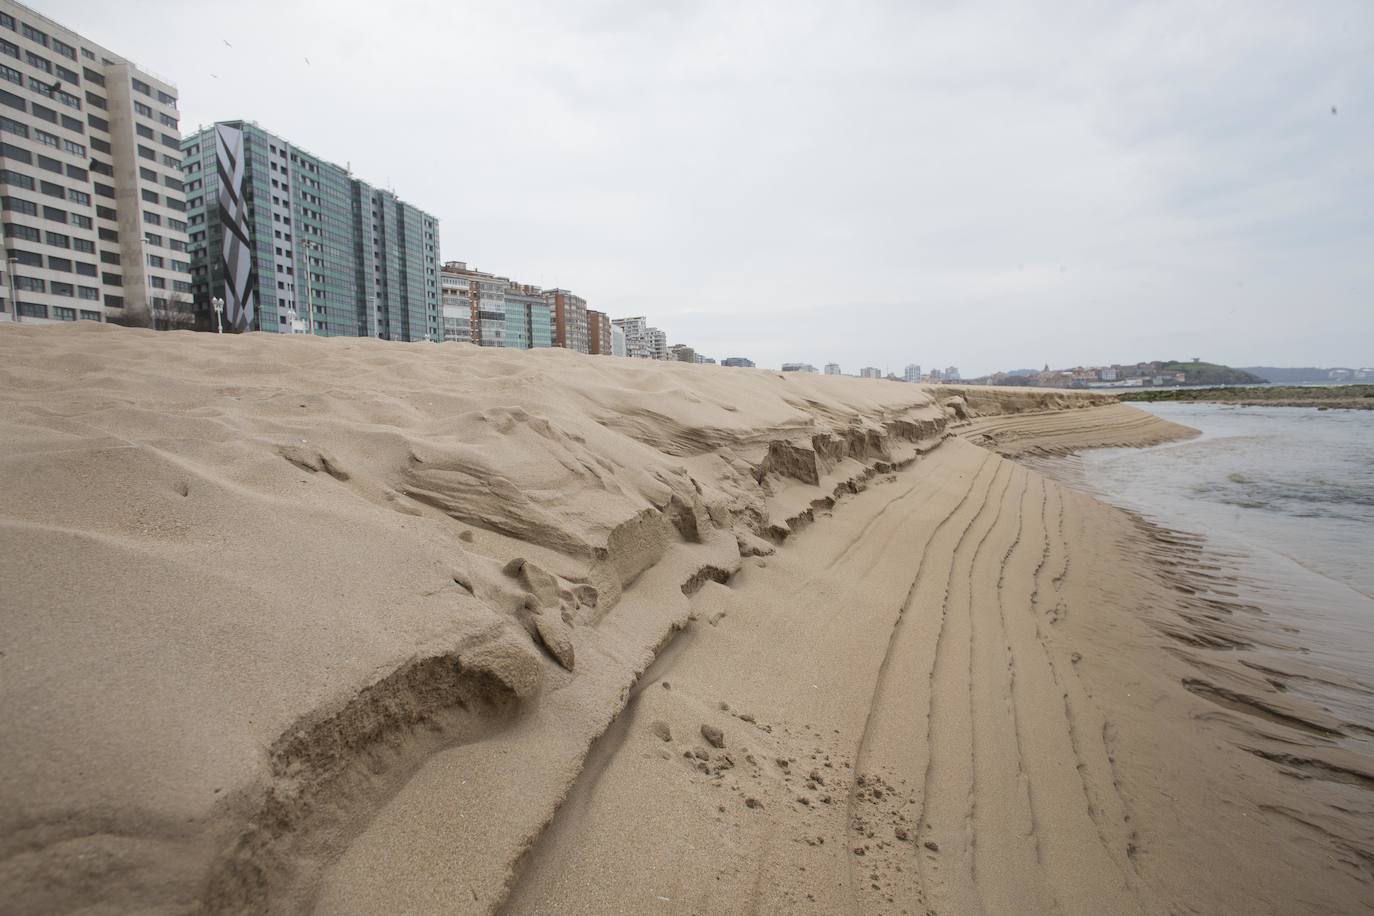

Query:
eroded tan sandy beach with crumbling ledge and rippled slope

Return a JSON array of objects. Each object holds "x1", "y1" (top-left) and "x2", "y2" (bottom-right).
[{"x1": 0, "y1": 323, "x2": 1374, "y2": 913}]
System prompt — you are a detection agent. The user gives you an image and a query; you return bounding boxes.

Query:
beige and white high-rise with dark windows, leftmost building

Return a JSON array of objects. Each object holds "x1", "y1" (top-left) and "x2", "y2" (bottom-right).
[{"x1": 0, "y1": 0, "x2": 191, "y2": 327}]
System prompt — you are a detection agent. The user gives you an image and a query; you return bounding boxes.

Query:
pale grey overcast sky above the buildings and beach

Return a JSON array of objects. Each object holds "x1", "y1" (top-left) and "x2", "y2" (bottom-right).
[{"x1": 42, "y1": 0, "x2": 1374, "y2": 376}]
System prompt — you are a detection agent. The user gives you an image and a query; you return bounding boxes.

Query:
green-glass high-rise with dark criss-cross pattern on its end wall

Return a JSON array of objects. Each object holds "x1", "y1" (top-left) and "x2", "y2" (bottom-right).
[{"x1": 181, "y1": 121, "x2": 439, "y2": 341}]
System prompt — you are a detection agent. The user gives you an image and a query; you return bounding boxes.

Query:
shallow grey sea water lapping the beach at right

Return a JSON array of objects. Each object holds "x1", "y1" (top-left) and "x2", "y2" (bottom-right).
[{"x1": 1046, "y1": 402, "x2": 1374, "y2": 721}]
